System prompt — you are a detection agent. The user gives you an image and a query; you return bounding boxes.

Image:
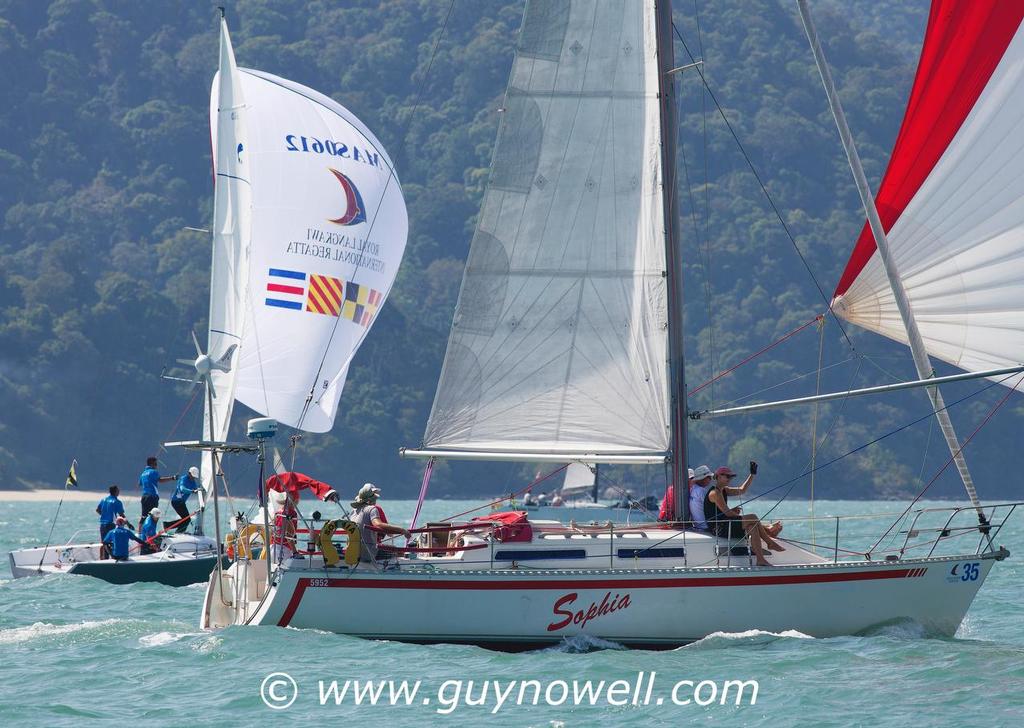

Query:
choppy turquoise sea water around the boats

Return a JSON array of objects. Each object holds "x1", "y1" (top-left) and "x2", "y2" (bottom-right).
[{"x1": 0, "y1": 501, "x2": 1024, "y2": 728}]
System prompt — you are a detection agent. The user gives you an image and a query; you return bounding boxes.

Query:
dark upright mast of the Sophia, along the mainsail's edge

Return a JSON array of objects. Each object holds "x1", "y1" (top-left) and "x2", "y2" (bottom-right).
[{"x1": 654, "y1": 0, "x2": 689, "y2": 520}]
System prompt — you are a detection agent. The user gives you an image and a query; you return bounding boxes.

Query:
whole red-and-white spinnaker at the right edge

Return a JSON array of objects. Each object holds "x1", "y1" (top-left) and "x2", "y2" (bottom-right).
[{"x1": 834, "y1": 0, "x2": 1024, "y2": 382}]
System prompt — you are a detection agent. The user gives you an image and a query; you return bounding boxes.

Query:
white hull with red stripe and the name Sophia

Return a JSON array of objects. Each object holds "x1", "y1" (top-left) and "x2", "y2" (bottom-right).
[{"x1": 204, "y1": 552, "x2": 1005, "y2": 649}]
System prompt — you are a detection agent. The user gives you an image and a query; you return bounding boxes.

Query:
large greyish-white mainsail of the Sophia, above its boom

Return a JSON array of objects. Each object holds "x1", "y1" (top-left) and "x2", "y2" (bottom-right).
[{"x1": 424, "y1": 0, "x2": 670, "y2": 455}]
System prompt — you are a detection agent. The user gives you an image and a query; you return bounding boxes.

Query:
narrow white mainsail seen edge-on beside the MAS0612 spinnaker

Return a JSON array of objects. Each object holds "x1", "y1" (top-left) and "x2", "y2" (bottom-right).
[{"x1": 201, "y1": 18, "x2": 252, "y2": 495}]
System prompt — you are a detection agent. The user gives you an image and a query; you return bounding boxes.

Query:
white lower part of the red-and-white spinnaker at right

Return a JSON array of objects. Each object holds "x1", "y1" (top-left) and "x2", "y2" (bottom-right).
[{"x1": 834, "y1": 26, "x2": 1024, "y2": 376}]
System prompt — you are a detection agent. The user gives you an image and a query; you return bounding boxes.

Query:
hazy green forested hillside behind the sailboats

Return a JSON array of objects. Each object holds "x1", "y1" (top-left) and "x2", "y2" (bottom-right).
[{"x1": 0, "y1": 0, "x2": 1024, "y2": 498}]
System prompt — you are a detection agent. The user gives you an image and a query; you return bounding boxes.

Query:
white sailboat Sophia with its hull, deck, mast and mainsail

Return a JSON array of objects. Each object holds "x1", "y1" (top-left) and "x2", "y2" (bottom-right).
[{"x1": 202, "y1": 0, "x2": 1024, "y2": 649}]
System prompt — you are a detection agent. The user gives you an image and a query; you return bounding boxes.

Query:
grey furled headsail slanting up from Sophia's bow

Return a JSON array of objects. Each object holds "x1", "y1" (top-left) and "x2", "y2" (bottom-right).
[{"x1": 797, "y1": 0, "x2": 988, "y2": 532}]
